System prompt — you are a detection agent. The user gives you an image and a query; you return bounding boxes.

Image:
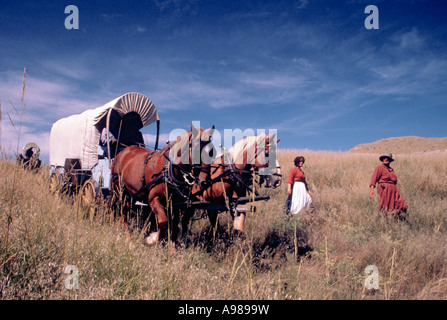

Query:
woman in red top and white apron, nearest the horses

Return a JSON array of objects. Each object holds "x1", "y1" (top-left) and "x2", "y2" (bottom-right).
[{"x1": 287, "y1": 156, "x2": 312, "y2": 214}]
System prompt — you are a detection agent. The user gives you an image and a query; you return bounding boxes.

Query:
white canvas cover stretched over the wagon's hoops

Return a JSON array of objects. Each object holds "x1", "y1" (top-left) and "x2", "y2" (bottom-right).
[{"x1": 50, "y1": 92, "x2": 159, "y2": 169}]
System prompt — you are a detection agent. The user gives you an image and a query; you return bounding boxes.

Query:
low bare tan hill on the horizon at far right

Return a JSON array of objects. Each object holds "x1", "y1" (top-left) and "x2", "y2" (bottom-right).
[{"x1": 349, "y1": 136, "x2": 447, "y2": 154}]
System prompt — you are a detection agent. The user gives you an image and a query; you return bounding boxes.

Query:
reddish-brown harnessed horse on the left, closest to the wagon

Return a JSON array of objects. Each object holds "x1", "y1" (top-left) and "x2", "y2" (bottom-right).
[{"x1": 112, "y1": 126, "x2": 214, "y2": 245}]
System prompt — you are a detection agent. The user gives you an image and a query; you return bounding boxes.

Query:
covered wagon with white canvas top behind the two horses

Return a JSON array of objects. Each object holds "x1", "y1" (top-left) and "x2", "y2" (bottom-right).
[{"x1": 49, "y1": 92, "x2": 160, "y2": 201}]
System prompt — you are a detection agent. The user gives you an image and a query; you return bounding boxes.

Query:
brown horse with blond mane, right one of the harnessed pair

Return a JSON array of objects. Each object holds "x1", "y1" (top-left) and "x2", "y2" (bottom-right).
[{"x1": 190, "y1": 134, "x2": 282, "y2": 238}]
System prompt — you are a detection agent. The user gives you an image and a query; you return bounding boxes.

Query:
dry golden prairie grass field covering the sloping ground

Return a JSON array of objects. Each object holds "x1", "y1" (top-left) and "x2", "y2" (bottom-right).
[{"x1": 0, "y1": 149, "x2": 447, "y2": 300}]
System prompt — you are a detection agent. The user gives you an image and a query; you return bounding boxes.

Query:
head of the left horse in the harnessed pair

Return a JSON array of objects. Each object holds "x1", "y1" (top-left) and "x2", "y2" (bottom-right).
[{"x1": 170, "y1": 125, "x2": 214, "y2": 191}]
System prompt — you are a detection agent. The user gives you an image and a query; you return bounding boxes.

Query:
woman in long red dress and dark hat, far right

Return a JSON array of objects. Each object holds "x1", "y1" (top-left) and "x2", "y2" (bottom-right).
[{"x1": 369, "y1": 153, "x2": 408, "y2": 218}]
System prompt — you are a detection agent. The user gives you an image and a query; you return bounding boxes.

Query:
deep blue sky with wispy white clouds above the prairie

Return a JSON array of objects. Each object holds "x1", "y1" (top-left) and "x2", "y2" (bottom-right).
[{"x1": 0, "y1": 0, "x2": 447, "y2": 160}]
